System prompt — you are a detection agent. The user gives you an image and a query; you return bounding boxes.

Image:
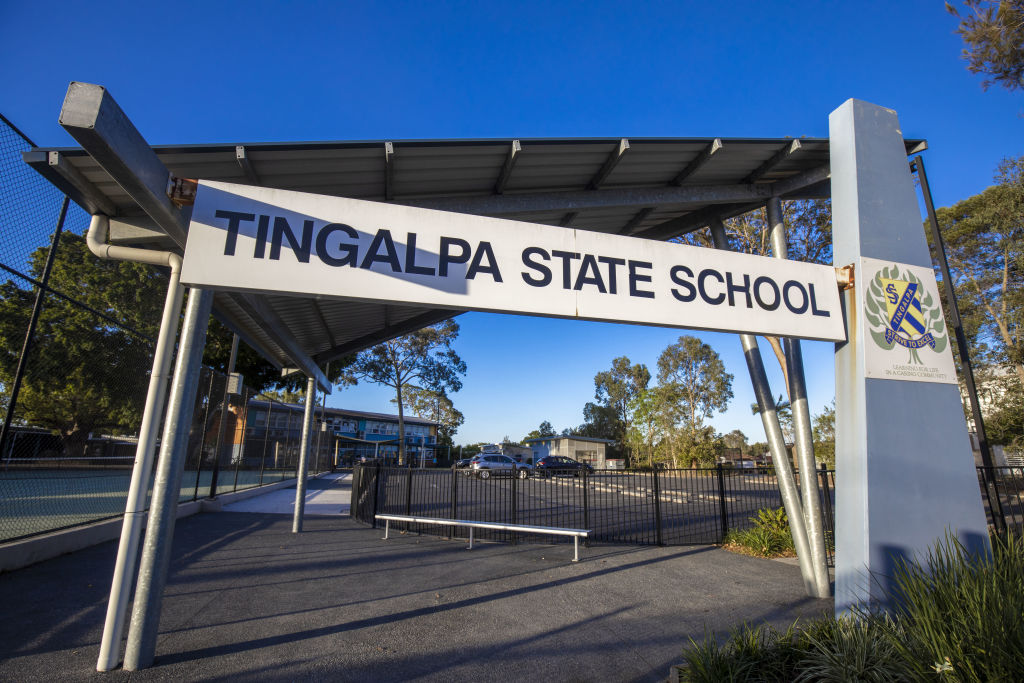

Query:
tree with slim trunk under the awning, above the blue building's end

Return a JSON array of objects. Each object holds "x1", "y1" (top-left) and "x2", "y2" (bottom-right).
[{"x1": 347, "y1": 319, "x2": 466, "y2": 464}]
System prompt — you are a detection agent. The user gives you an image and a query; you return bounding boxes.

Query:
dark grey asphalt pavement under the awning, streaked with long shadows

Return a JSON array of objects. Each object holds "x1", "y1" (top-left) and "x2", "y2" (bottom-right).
[{"x1": 0, "y1": 479, "x2": 831, "y2": 681}]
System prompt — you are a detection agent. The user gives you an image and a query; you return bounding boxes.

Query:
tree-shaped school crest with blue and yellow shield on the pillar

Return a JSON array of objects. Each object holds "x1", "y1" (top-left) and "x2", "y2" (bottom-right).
[{"x1": 865, "y1": 264, "x2": 948, "y2": 365}]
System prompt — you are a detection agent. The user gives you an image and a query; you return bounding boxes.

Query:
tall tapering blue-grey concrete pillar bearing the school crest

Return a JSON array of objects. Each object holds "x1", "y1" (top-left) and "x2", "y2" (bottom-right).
[{"x1": 828, "y1": 99, "x2": 988, "y2": 613}]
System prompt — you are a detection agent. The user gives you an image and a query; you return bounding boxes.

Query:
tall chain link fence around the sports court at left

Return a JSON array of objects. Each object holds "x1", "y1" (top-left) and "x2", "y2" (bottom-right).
[{"x1": 0, "y1": 115, "x2": 333, "y2": 543}]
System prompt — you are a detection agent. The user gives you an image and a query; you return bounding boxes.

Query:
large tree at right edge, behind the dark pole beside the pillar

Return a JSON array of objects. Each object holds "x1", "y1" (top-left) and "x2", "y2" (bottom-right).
[{"x1": 936, "y1": 157, "x2": 1024, "y2": 384}]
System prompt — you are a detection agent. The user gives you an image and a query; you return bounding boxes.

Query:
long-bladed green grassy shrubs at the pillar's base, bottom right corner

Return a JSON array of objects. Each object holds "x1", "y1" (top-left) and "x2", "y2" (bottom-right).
[{"x1": 683, "y1": 532, "x2": 1024, "y2": 682}]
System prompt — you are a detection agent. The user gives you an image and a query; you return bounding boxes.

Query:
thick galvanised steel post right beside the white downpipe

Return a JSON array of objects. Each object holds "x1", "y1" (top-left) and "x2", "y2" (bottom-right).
[{"x1": 125, "y1": 289, "x2": 213, "y2": 671}]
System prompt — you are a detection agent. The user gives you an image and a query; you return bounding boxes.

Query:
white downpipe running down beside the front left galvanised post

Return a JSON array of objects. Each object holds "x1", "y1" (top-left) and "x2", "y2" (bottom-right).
[{"x1": 96, "y1": 253, "x2": 184, "y2": 671}]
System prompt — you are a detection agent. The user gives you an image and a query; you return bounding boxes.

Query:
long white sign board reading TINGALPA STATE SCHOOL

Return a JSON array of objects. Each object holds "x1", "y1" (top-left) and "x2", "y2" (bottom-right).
[{"x1": 181, "y1": 180, "x2": 846, "y2": 341}]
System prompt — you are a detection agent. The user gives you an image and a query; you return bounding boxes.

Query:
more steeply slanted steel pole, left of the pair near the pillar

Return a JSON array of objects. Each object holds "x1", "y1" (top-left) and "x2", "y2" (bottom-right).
[{"x1": 710, "y1": 220, "x2": 815, "y2": 597}]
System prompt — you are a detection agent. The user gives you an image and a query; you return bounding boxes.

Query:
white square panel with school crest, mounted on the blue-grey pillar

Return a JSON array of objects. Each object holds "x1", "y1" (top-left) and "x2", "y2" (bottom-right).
[{"x1": 857, "y1": 258, "x2": 956, "y2": 384}]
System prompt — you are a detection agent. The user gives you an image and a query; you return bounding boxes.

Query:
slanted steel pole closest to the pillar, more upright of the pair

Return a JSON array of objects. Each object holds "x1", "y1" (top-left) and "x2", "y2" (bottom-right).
[{"x1": 766, "y1": 197, "x2": 831, "y2": 598}]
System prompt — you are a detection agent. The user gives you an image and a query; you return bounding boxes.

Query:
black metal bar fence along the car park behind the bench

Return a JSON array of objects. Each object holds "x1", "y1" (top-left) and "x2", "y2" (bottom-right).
[{"x1": 351, "y1": 464, "x2": 835, "y2": 558}]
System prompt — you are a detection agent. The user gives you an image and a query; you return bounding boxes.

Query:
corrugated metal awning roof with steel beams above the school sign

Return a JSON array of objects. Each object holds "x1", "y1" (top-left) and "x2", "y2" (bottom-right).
[{"x1": 24, "y1": 84, "x2": 926, "y2": 393}]
